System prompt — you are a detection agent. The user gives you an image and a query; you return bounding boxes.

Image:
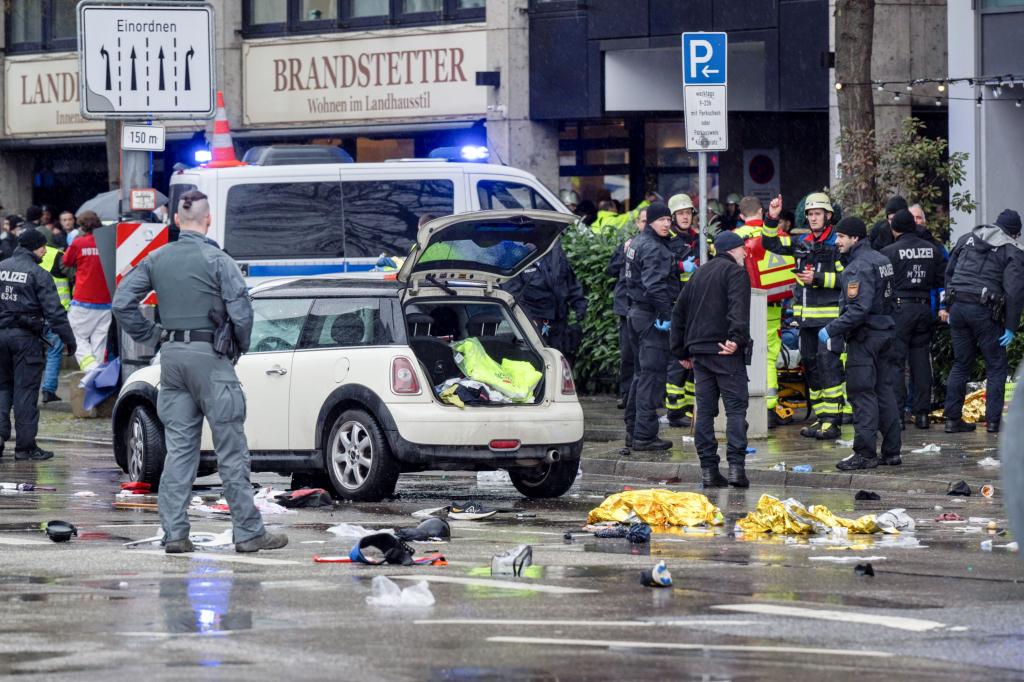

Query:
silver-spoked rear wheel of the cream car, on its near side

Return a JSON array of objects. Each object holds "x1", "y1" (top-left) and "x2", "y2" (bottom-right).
[{"x1": 324, "y1": 410, "x2": 399, "y2": 502}]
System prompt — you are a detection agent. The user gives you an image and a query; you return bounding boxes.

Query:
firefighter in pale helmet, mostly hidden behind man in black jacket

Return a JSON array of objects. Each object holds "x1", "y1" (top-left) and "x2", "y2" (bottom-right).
[{"x1": 665, "y1": 194, "x2": 700, "y2": 428}]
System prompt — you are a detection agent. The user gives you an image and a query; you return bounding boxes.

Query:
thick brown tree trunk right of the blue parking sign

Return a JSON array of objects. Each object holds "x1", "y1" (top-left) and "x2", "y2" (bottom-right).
[{"x1": 836, "y1": 0, "x2": 876, "y2": 204}]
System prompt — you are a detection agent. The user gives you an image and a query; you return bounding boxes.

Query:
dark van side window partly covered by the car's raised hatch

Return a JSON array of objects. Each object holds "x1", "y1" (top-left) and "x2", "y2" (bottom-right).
[{"x1": 341, "y1": 179, "x2": 455, "y2": 258}]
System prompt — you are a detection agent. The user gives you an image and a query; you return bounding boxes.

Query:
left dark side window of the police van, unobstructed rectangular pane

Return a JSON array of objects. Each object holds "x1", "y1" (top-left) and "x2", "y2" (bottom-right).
[{"x1": 224, "y1": 182, "x2": 344, "y2": 259}]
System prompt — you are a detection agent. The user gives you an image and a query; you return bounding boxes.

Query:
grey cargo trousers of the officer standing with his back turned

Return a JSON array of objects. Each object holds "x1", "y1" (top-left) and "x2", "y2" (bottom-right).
[{"x1": 157, "y1": 341, "x2": 265, "y2": 543}]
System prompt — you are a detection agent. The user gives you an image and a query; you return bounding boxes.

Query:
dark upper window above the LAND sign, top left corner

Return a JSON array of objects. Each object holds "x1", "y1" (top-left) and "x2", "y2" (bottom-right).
[{"x1": 3, "y1": 0, "x2": 78, "y2": 52}]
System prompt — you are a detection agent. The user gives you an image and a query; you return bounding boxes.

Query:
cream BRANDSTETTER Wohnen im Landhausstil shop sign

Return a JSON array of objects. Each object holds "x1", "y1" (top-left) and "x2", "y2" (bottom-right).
[{"x1": 243, "y1": 30, "x2": 487, "y2": 125}]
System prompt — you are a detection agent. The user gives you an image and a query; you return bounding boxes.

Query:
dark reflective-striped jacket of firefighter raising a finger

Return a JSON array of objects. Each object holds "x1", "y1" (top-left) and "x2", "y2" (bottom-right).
[{"x1": 761, "y1": 218, "x2": 843, "y2": 329}]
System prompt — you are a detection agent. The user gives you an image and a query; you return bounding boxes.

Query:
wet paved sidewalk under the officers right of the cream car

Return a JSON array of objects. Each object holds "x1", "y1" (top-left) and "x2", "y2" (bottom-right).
[{"x1": 581, "y1": 396, "x2": 1001, "y2": 496}]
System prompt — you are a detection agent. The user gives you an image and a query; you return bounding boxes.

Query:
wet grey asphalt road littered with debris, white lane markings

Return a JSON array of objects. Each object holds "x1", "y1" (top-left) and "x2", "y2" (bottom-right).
[{"x1": 0, "y1": 445, "x2": 1024, "y2": 681}]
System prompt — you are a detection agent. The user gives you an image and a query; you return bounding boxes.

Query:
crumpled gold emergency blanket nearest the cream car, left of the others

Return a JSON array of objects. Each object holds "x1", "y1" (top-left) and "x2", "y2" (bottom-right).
[{"x1": 587, "y1": 488, "x2": 725, "y2": 526}]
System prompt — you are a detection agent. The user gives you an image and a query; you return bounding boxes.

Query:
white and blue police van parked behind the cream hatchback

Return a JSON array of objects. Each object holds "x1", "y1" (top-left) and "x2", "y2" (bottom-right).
[{"x1": 168, "y1": 145, "x2": 569, "y2": 286}]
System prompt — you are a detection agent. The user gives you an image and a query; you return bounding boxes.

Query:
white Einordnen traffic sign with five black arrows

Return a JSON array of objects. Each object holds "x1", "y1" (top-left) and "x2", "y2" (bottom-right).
[{"x1": 78, "y1": 0, "x2": 215, "y2": 119}]
